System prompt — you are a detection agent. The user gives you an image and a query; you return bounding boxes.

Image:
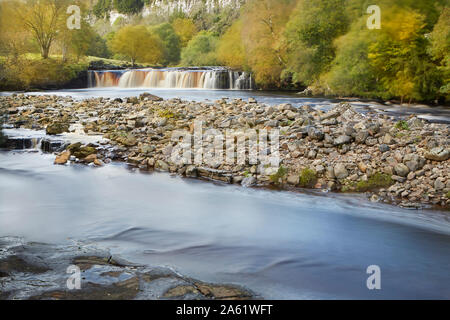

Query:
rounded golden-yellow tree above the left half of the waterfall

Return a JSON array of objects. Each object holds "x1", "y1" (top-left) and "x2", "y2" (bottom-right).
[{"x1": 110, "y1": 26, "x2": 163, "y2": 66}]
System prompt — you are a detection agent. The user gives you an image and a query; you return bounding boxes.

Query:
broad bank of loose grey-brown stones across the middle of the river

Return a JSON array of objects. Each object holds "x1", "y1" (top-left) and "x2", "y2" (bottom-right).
[{"x1": 0, "y1": 94, "x2": 450, "y2": 209}]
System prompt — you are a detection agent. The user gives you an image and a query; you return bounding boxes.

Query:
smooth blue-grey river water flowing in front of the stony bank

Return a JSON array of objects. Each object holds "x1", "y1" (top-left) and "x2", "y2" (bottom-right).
[{"x1": 0, "y1": 151, "x2": 450, "y2": 299}]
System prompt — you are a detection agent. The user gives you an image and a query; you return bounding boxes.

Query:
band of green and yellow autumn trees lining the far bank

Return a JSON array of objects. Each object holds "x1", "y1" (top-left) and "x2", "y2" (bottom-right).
[{"x1": 0, "y1": 0, "x2": 450, "y2": 103}]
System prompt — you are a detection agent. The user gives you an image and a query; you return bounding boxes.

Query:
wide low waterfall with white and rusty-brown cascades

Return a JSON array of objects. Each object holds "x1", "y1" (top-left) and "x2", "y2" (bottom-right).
[{"x1": 88, "y1": 68, "x2": 254, "y2": 90}]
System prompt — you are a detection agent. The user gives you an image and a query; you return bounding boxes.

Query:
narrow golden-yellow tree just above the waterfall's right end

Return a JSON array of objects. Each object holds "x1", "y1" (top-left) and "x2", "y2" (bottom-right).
[{"x1": 217, "y1": 20, "x2": 247, "y2": 70}]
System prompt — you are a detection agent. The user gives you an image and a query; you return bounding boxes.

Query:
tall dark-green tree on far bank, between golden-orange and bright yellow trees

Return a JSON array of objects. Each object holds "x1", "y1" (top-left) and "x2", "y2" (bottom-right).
[{"x1": 286, "y1": 0, "x2": 349, "y2": 85}]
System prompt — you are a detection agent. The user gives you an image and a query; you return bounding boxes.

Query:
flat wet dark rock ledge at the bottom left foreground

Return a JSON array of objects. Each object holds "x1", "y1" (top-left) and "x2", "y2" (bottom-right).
[{"x1": 0, "y1": 237, "x2": 256, "y2": 300}]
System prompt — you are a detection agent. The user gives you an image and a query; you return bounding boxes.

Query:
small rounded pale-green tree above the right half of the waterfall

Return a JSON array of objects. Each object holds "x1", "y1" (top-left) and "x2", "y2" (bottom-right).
[{"x1": 181, "y1": 31, "x2": 218, "y2": 66}]
